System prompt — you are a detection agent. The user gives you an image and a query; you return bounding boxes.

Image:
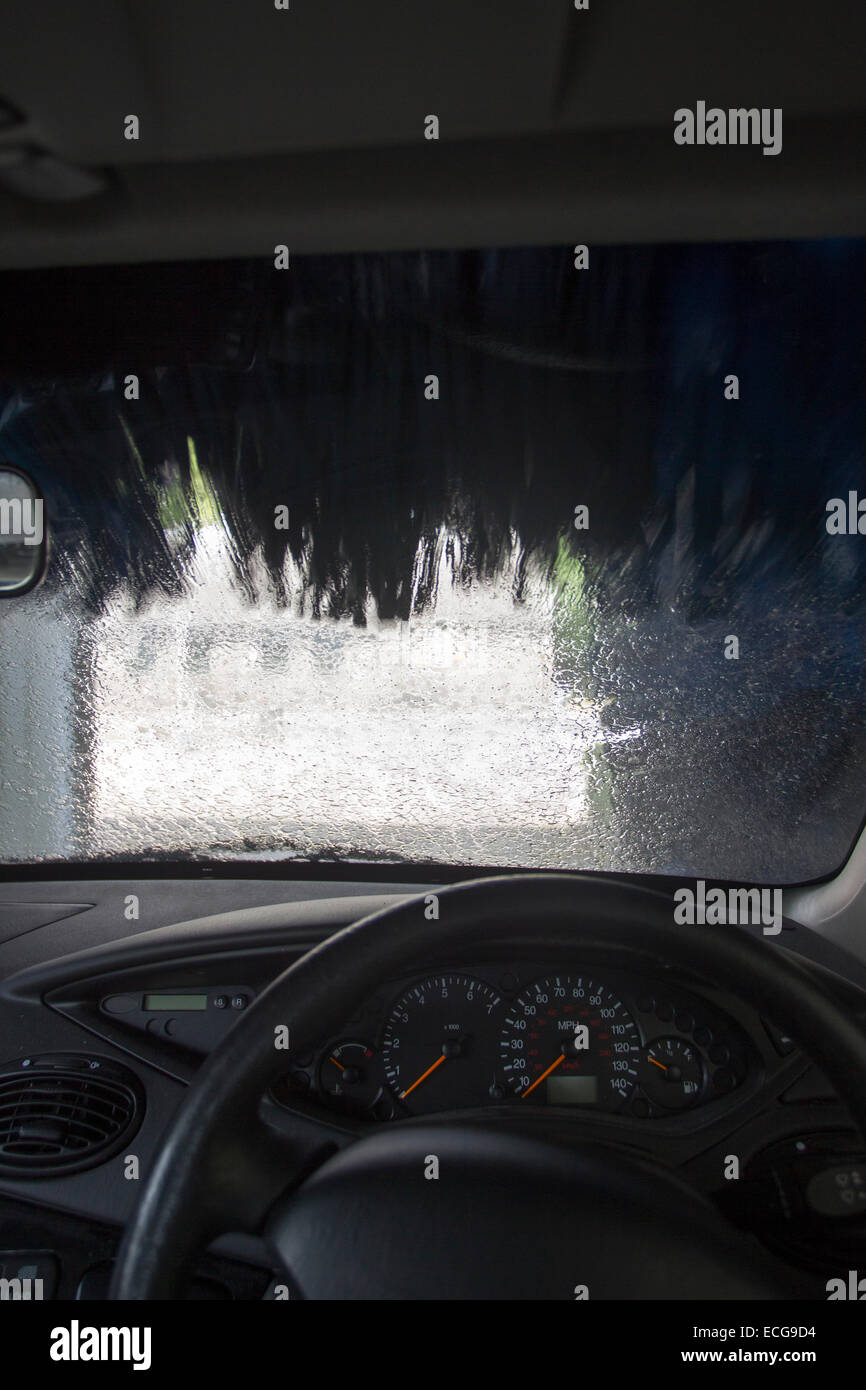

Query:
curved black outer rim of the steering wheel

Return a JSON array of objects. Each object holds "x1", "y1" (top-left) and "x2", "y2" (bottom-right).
[{"x1": 110, "y1": 873, "x2": 866, "y2": 1300}]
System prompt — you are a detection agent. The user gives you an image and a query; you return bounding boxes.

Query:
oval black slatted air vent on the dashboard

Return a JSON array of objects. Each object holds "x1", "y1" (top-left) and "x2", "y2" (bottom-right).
[{"x1": 0, "y1": 1054, "x2": 145, "y2": 1179}]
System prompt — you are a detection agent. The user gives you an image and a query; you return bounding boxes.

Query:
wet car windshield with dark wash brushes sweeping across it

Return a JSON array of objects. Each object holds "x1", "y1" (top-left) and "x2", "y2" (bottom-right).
[{"x1": 0, "y1": 240, "x2": 866, "y2": 883}]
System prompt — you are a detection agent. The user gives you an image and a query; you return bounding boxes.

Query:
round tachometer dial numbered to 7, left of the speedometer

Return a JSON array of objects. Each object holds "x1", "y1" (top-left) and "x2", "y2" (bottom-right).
[{"x1": 382, "y1": 974, "x2": 500, "y2": 1115}]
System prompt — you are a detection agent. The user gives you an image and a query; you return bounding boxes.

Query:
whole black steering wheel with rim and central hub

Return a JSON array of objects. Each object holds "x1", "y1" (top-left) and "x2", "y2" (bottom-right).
[{"x1": 110, "y1": 874, "x2": 866, "y2": 1300}]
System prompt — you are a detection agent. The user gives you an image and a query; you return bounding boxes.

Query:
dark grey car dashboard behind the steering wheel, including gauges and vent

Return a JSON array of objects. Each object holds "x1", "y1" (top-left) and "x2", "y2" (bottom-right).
[{"x1": 0, "y1": 881, "x2": 866, "y2": 1300}]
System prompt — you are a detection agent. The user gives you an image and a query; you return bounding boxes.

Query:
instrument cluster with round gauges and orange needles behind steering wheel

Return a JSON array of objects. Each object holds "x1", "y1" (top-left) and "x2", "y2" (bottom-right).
[{"x1": 286, "y1": 965, "x2": 751, "y2": 1120}]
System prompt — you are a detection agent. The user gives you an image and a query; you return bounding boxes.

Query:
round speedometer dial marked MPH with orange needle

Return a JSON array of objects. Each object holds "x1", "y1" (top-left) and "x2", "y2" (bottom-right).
[{"x1": 499, "y1": 974, "x2": 641, "y2": 1109}]
